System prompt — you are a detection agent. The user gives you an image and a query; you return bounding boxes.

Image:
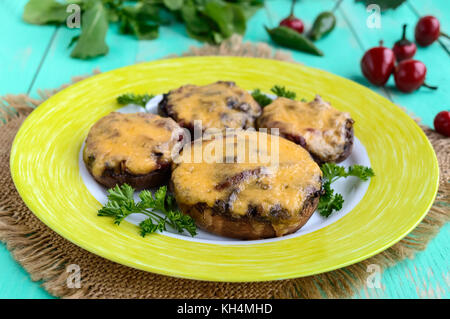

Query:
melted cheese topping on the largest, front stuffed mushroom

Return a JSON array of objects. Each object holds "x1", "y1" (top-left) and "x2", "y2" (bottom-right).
[{"x1": 172, "y1": 131, "x2": 322, "y2": 219}]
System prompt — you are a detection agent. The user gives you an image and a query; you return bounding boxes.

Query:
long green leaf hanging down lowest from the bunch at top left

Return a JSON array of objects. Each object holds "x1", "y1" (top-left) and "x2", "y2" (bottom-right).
[{"x1": 70, "y1": 0, "x2": 108, "y2": 59}]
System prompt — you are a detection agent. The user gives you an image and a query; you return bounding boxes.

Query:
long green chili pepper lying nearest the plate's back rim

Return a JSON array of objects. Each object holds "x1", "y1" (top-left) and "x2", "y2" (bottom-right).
[{"x1": 265, "y1": 26, "x2": 323, "y2": 56}]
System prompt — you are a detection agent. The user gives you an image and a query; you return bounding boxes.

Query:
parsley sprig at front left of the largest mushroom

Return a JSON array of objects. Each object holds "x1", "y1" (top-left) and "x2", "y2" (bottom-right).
[{"x1": 98, "y1": 184, "x2": 197, "y2": 237}]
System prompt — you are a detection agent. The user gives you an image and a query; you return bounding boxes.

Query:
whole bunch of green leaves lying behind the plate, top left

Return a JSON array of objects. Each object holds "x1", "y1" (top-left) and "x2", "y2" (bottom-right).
[{"x1": 23, "y1": 0, "x2": 264, "y2": 59}]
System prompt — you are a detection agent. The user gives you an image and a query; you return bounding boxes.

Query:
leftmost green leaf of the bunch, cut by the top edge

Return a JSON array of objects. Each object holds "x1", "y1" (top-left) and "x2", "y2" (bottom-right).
[{"x1": 23, "y1": 0, "x2": 70, "y2": 24}]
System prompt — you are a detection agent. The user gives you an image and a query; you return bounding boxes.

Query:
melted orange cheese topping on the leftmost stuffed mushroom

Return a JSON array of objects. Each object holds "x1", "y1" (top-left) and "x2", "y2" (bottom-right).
[{"x1": 83, "y1": 112, "x2": 183, "y2": 177}]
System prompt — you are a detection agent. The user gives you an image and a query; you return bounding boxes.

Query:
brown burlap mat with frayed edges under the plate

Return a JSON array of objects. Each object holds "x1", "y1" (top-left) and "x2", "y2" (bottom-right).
[{"x1": 0, "y1": 37, "x2": 450, "y2": 298}]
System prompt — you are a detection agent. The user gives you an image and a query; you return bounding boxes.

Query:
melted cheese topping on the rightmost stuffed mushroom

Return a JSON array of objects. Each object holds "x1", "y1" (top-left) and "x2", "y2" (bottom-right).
[{"x1": 259, "y1": 96, "x2": 351, "y2": 157}]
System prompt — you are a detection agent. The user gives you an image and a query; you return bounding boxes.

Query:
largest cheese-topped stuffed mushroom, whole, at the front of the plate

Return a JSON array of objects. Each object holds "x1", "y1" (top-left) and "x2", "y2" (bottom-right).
[{"x1": 171, "y1": 131, "x2": 322, "y2": 240}]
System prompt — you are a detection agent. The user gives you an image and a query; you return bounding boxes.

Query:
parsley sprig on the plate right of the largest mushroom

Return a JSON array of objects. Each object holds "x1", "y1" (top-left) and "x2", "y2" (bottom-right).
[{"x1": 317, "y1": 163, "x2": 375, "y2": 217}]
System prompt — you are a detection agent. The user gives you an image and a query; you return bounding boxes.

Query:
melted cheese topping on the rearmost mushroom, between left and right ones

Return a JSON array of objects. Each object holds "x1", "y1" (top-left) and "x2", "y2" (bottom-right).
[{"x1": 167, "y1": 82, "x2": 261, "y2": 129}]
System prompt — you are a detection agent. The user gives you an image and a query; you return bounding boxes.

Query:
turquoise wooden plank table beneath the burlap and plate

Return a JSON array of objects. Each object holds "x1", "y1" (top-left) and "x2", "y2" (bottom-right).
[{"x1": 0, "y1": 0, "x2": 450, "y2": 298}]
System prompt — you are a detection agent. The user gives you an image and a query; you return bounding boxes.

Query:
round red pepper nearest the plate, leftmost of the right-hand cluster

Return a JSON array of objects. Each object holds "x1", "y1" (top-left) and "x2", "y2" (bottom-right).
[{"x1": 361, "y1": 41, "x2": 395, "y2": 85}]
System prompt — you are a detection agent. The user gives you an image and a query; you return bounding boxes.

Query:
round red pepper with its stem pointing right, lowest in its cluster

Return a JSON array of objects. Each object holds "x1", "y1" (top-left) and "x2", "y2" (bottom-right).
[{"x1": 394, "y1": 60, "x2": 437, "y2": 93}]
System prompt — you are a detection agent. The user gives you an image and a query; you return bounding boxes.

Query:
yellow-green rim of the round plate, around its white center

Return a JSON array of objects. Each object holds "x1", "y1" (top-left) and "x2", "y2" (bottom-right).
[{"x1": 11, "y1": 57, "x2": 439, "y2": 281}]
